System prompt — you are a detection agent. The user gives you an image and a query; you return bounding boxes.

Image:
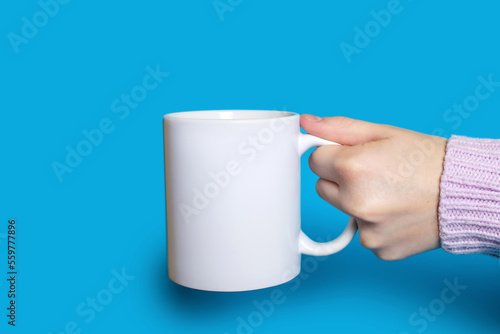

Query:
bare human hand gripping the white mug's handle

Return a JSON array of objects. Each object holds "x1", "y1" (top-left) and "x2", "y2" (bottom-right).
[{"x1": 300, "y1": 115, "x2": 447, "y2": 261}]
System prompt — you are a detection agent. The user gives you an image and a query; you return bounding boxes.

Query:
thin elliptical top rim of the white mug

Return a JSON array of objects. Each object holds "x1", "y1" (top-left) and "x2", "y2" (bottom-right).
[{"x1": 163, "y1": 109, "x2": 299, "y2": 122}]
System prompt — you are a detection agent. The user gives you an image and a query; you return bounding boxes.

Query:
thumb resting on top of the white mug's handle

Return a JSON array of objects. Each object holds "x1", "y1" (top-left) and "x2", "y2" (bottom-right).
[{"x1": 300, "y1": 115, "x2": 396, "y2": 146}]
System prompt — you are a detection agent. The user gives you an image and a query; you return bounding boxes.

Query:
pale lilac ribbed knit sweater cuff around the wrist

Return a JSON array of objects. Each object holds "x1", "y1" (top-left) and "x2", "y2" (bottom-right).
[{"x1": 439, "y1": 136, "x2": 500, "y2": 257}]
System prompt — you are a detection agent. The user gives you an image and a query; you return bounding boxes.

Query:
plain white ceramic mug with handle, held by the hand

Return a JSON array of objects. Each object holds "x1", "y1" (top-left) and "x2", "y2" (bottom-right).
[{"x1": 163, "y1": 110, "x2": 357, "y2": 291}]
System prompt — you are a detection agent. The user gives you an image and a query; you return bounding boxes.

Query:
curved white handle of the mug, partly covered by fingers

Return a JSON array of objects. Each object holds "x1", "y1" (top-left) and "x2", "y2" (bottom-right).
[{"x1": 299, "y1": 133, "x2": 358, "y2": 256}]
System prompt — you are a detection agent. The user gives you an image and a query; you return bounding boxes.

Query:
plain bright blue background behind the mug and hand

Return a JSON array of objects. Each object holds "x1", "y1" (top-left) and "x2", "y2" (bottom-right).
[{"x1": 0, "y1": 0, "x2": 500, "y2": 334}]
